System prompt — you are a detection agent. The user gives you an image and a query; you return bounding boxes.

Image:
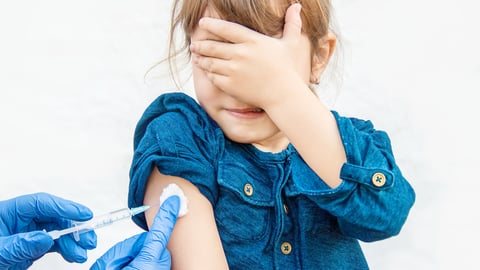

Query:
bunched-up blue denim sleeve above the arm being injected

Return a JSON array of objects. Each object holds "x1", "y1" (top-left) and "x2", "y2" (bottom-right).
[{"x1": 128, "y1": 95, "x2": 217, "y2": 229}]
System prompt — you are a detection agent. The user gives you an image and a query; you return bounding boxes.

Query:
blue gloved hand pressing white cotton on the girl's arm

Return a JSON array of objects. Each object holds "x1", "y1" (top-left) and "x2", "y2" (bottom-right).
[{"x1": 90, "y1": 196, "x2": 180, "y2": 270}]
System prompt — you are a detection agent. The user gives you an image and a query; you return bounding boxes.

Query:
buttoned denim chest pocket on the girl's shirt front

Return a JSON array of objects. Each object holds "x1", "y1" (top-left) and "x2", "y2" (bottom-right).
[{"x1": 214, "y1": 162, "x2": 274, "y2": 241}]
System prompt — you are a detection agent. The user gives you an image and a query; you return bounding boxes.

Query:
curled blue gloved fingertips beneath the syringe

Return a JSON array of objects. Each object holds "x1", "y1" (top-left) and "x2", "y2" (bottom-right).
[{"x1": 50, "y1": 231, "x2": 97, "y2": 263}]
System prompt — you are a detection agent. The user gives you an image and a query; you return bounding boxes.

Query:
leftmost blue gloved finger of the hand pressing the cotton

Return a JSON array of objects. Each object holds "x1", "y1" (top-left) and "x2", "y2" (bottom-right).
[{"x1": 90, "y1": 232, "x2": 147, "y2": 270}]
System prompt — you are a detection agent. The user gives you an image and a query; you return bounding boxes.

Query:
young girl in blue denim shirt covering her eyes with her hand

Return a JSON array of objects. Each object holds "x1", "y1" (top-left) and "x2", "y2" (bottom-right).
[{"x1": 129, "y1": 0, "x2": 415, "y2": 270}]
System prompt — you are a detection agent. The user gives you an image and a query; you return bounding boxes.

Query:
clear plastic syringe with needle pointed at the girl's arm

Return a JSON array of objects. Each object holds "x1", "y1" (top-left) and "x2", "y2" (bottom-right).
[{"x1": 48, "y1": 205, "x2": 150, "y2": 241}]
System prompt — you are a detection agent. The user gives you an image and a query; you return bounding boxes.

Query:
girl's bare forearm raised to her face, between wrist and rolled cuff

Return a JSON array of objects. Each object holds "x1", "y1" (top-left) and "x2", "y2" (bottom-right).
[{"x1": 265, "y1": 82, "x2": 347, "y2": 188}]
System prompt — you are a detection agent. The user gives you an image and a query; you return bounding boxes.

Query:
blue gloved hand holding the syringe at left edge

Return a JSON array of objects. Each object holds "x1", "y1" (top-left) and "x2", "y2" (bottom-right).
[{"x1": 0, "y1": 193, "x2": 97, "y2": 269}]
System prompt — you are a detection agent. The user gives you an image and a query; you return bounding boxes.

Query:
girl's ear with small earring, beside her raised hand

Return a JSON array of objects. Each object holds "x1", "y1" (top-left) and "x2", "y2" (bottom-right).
[{"x1": 310, "y1": 33, "x2": 337, "y2": 84}]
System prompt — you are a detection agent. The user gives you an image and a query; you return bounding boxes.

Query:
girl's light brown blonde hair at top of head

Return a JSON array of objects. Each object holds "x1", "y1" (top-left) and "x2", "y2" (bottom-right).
[{"x1": 166, "y1": 0, "x2": 331, "y2": 90}]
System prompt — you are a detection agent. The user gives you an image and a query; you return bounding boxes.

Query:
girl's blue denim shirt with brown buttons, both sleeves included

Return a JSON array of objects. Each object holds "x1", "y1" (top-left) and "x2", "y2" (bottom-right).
[{"x1": 128, "y1": 93, "x2": 415, "y2": 269}]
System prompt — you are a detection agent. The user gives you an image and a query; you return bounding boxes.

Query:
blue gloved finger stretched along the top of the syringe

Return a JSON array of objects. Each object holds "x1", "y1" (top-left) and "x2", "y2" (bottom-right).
[{"x1": 16, "y1": 193, "x2": 93, "y2": 222}]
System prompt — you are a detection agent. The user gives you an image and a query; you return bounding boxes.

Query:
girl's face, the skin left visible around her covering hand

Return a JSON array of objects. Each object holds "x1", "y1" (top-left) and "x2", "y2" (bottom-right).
[{"x1": 191, "y1": 6, "x2": 311, "y2": 153}]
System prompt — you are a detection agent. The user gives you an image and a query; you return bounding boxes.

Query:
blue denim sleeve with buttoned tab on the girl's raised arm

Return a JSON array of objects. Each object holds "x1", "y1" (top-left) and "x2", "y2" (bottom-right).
[{"x1": 298, "y1": 112, "x2": 415, "y2": 242}]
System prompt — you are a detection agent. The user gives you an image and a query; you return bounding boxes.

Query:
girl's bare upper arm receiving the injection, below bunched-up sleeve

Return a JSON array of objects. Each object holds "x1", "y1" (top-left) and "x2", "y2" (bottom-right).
[{"x1": 144, "y1": 168, "x2": 228, "y2": 270}]
